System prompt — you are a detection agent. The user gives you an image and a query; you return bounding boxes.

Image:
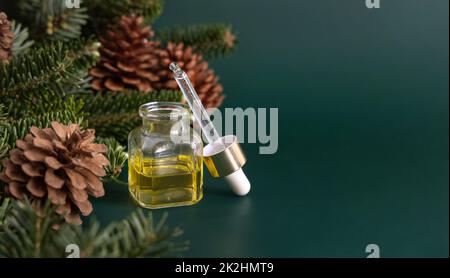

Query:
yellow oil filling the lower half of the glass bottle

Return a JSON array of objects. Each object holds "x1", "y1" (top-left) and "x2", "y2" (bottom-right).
[{"x1": 128, "y1": 154, "x2": 203, "y2": 208}]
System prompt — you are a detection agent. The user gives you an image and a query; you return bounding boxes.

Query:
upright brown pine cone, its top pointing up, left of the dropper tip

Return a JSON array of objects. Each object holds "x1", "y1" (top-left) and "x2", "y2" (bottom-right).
[{"x1": 90, "y1": 15, "x2": 158, "y2": 92}]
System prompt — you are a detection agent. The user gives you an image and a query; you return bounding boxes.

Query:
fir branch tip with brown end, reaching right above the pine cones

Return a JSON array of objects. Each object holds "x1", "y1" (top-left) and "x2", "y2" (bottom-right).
[{"x1": 157, "y1": 24, "x2": 237, "y2": 58}]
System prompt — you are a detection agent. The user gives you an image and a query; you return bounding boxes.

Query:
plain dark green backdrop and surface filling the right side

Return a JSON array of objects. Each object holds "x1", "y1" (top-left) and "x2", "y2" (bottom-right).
[{"x1": 1, "y1": 0, "x2": 449, "y2": 257}]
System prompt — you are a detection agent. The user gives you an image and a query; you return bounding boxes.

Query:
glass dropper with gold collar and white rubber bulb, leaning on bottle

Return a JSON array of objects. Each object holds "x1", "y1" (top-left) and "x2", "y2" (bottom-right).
[{"x1": 169, "y1": 63, "x2": 250, "y2": 196}]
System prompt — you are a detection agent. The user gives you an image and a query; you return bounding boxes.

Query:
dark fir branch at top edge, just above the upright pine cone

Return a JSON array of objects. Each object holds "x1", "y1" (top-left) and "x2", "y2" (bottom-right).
[{"x1": 85, "y1": 0, "x2": 164, "y2": 35}]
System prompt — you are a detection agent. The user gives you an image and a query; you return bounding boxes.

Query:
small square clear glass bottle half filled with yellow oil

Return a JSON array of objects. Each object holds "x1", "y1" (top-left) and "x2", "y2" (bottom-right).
[{"x1": 128, "y1": 102, "x2": 203, "y2": 208}]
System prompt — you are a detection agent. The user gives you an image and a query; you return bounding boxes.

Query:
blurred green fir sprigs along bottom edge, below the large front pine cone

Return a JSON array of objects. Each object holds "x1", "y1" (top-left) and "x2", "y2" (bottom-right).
[{"x1": 0, "y1": 199, "x2": 188, "y2": 258}]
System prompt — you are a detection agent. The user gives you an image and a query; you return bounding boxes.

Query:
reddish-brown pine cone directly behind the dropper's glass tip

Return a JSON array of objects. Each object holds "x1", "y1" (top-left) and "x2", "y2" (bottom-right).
[{"x1": 153, "y1": 42, "x2": 225, "y2": 108}]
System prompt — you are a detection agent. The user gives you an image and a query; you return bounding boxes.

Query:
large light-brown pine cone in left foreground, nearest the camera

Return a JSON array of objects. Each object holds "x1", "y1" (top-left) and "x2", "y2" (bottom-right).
[{"x1": 0, "y1": 122, "x2": 109, "y2": 224}]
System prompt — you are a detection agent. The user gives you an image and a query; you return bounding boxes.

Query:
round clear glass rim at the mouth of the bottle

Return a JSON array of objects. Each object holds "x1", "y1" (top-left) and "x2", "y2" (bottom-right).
[{"x1": 139, "y1": 101, "x2": 190, "y2": 121}]
